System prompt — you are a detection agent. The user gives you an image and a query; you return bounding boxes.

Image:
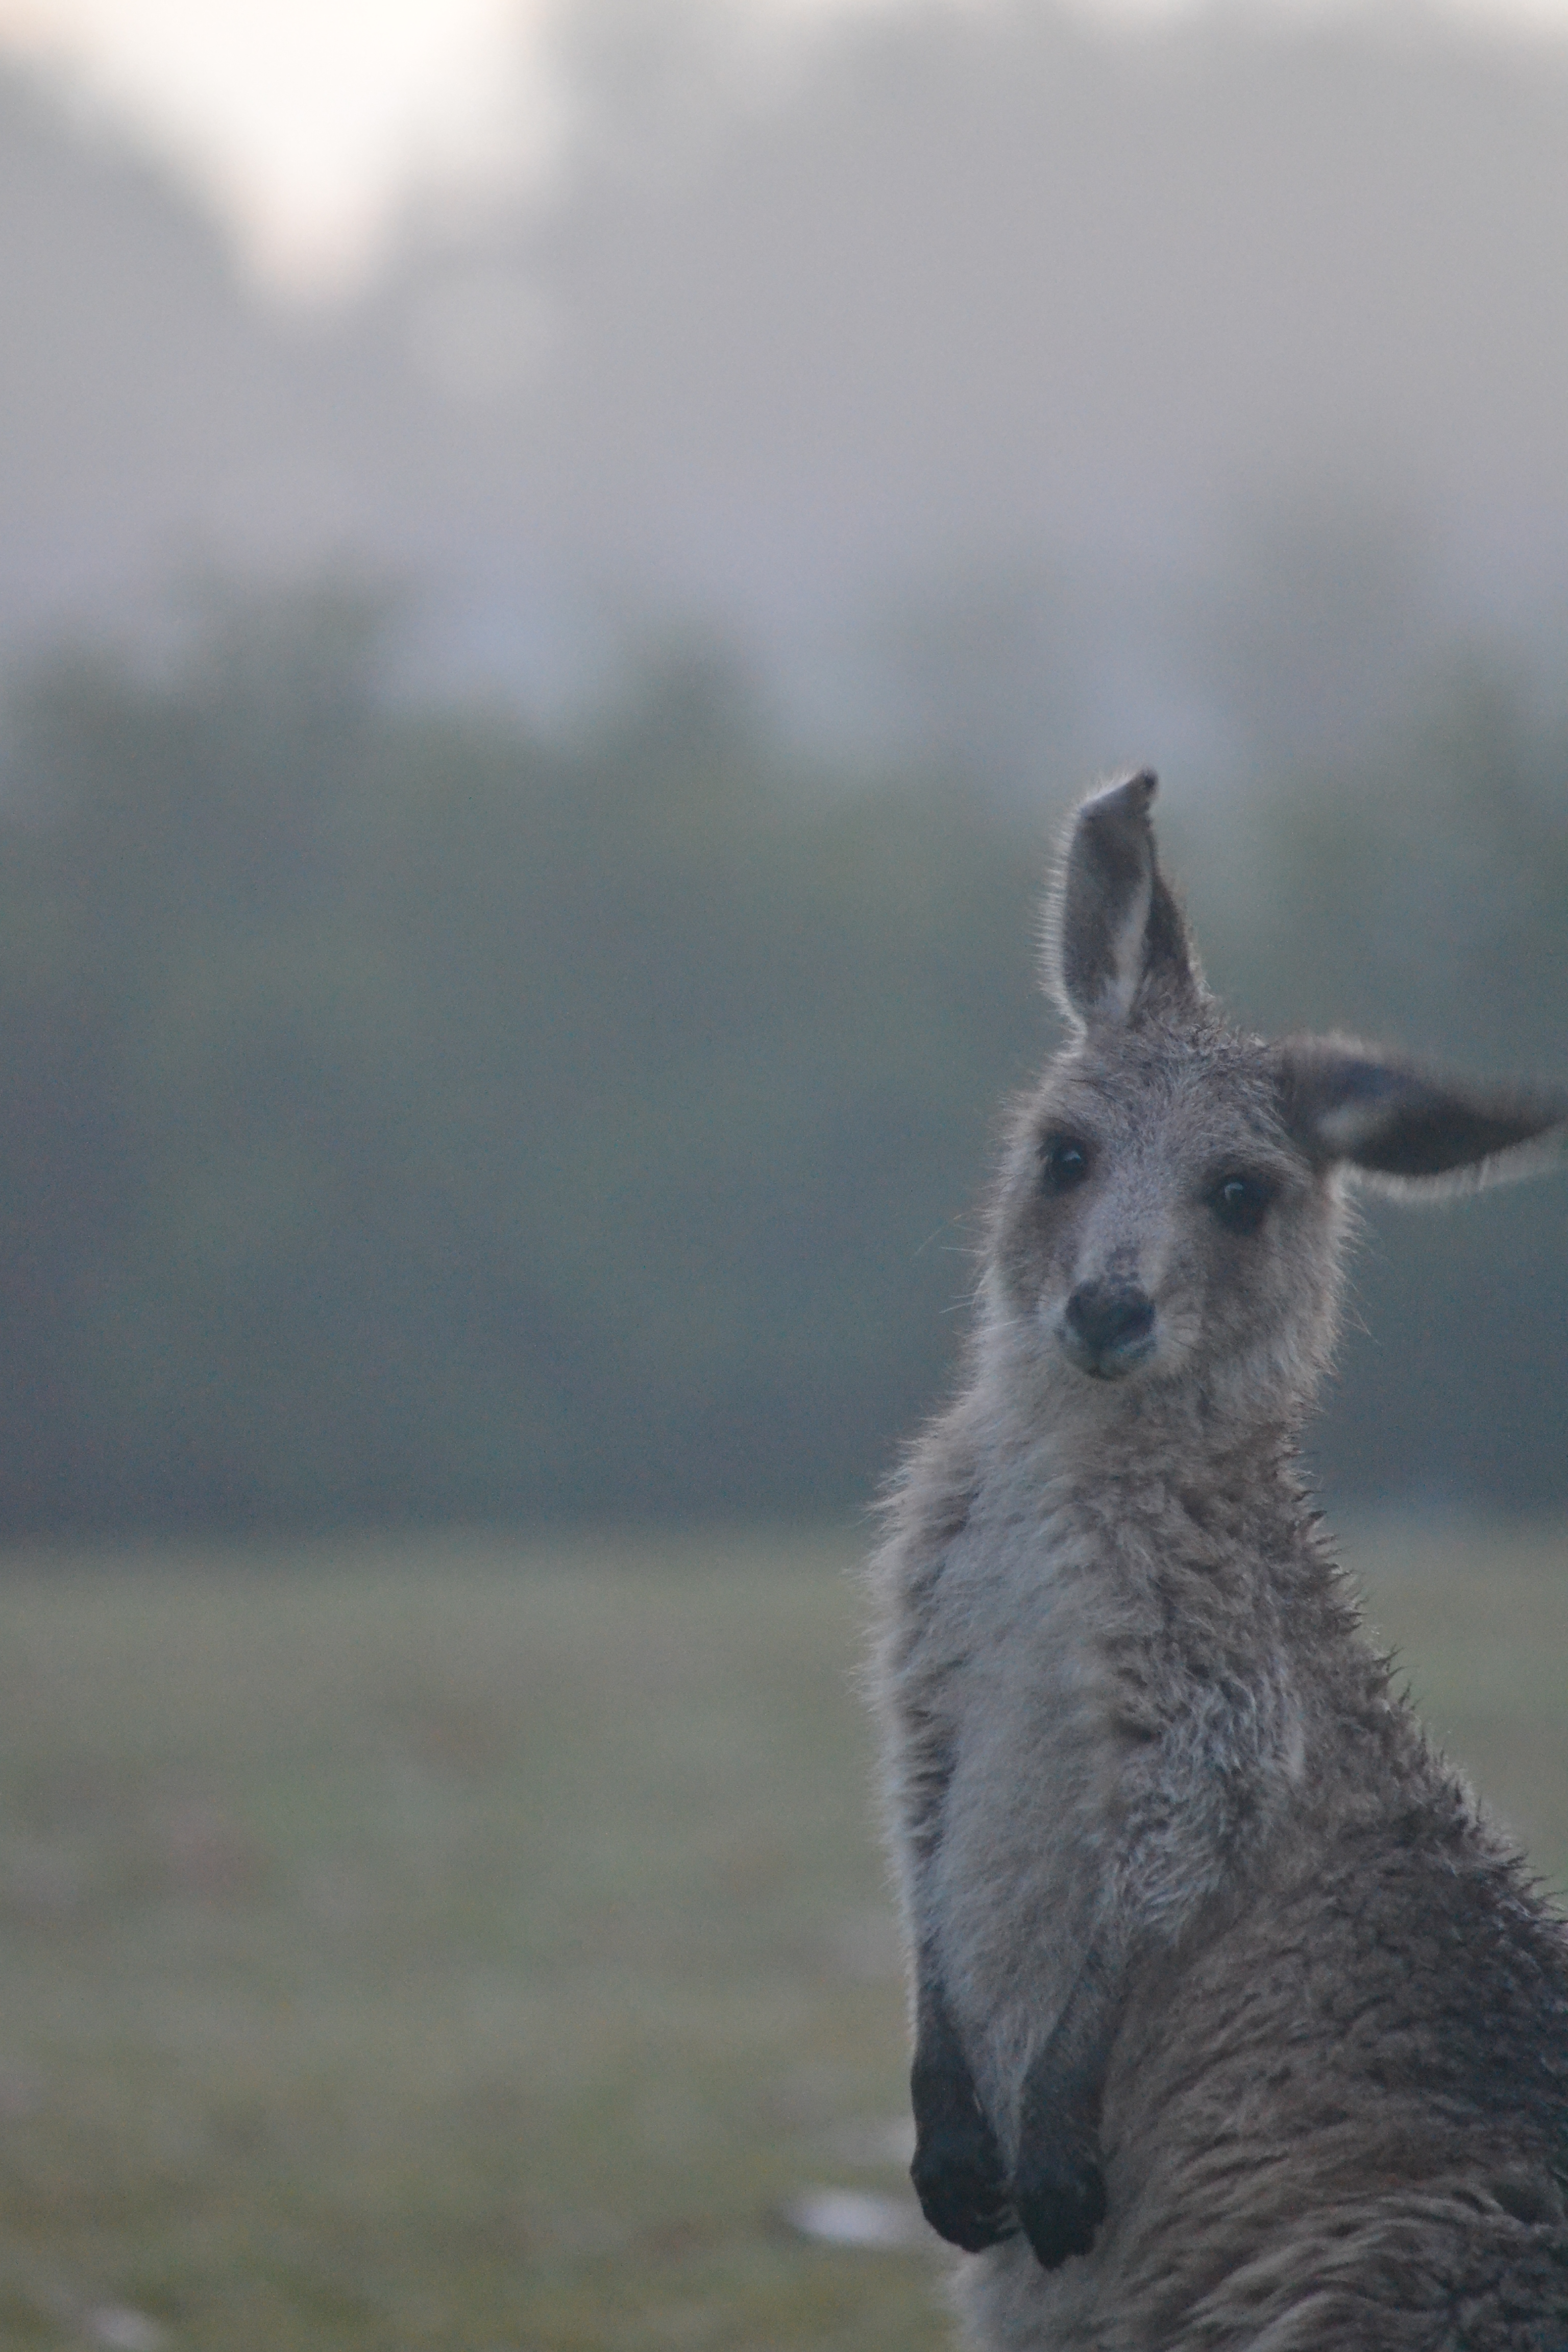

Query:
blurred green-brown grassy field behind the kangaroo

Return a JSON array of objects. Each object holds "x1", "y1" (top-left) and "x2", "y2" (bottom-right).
[{"x1": 0, "y1": 1527, "x2": 1568, "y2": 2352}]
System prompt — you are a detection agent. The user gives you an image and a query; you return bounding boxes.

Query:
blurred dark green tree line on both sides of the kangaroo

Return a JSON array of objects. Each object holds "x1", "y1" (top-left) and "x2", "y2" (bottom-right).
[{"x1": 0, "y1": 593, "x2": 1568, "y2": 1531}]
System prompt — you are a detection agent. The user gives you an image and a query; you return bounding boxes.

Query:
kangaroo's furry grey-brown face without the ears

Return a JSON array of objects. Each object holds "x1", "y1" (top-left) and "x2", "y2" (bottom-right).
[{"x1": 997, "y1": 1033, "x2": 1344, "y2": 1411}]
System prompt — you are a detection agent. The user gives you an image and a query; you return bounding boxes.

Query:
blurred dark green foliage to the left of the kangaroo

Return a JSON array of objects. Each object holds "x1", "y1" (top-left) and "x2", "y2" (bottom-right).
[{"x1": 0, "y1": 600, "x2": 1039, "y2": 1527}]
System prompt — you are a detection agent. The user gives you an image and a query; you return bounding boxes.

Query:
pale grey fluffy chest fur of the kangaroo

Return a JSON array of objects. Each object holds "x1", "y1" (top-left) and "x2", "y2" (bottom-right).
[{"x1": 931, "y1": 1512, "x2": 1300, "y2": 2131}]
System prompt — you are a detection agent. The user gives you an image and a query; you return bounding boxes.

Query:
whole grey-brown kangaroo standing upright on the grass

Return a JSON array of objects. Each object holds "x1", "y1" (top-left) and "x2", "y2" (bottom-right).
[{"x1": 872, "y1": 774, "x2": 1568, "y2": 2352}]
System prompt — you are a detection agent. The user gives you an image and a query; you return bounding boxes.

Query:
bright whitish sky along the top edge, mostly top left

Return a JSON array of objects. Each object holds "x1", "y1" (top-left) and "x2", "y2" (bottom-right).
[{"x1": 0, "y1": 0, "x2": 1568, "y2": 294}]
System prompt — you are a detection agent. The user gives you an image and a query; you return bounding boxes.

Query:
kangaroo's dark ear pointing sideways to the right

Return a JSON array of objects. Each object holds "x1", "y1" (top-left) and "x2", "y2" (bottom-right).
[{"x1": 1281, "y1": 1037, "x2": 1568, "y2": 1192}]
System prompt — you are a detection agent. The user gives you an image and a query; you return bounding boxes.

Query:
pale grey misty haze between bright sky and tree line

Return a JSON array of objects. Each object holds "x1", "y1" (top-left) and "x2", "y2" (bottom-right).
[{"x1": 0, "y1": 5, "x2": 1568, "y2": 757}]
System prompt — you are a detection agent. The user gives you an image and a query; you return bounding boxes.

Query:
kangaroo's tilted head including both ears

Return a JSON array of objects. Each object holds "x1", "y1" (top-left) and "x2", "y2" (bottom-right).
[{"x1": 987, "y1": 771, "x2": 1568, "y2": 1437}]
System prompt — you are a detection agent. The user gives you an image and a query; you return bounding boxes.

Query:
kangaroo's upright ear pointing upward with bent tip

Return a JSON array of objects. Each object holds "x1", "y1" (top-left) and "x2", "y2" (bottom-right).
[{"x1": 1046, "y1": 769, "x2": 1204, "y2": 1025}]
